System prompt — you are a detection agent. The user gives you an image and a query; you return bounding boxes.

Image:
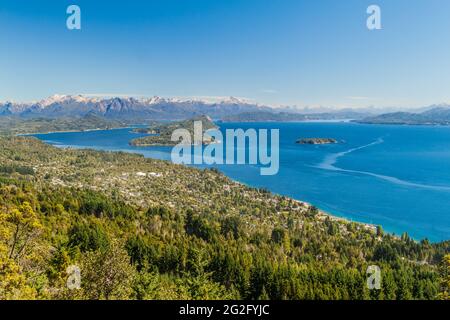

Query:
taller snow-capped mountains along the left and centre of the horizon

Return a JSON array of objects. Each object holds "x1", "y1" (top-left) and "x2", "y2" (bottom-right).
[{"x1": 0, "y1": 95, "x2": 272, "y2": 120}]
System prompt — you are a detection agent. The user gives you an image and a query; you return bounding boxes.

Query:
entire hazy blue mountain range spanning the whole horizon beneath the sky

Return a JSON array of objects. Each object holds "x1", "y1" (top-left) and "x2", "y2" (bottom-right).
[{"x1": 0, "y1": 95, "x2": 450, "y2": 125}]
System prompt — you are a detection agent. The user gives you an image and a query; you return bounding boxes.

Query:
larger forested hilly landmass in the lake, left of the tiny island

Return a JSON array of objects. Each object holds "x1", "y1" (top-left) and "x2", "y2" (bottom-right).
[{"x1": 130, "y1": 116, "x2": 218, "y2": 147}]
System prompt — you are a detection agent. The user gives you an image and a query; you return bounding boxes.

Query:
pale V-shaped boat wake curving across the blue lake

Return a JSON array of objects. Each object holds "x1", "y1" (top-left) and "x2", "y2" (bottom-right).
[{"x1": 315, "y1": 138, "x2": 450, "y2": 192}]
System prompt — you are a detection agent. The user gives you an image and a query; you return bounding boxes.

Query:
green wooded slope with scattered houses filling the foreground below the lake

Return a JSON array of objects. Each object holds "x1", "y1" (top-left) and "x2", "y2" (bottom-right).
[{"x1": 0, "y1": 137, "x2": 450, "y2": 299}]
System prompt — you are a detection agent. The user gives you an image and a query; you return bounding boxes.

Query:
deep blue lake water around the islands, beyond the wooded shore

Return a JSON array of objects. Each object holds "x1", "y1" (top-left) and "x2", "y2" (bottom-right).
[{"x1": 35, "y1": 123, "x2": 450, "y2": 241}]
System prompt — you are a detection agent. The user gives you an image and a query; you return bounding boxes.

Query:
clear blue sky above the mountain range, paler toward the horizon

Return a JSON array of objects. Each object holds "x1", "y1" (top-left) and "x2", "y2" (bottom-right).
[{"x1": 0, "y1": 0, "x2": 450, "y2": 107}]
